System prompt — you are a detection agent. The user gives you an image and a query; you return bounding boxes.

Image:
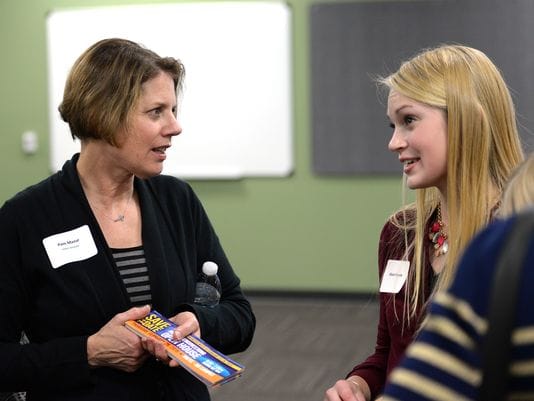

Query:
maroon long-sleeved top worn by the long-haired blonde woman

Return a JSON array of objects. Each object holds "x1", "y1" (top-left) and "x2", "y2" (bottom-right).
[{"x1": 347, "y1": 217, "x2": 434, "y2": 399}]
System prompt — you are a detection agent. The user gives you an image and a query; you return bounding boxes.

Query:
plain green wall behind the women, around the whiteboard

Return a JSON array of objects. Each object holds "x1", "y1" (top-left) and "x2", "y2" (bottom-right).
[{"x1": 0, "y1": 0, "x2": 401, "y2": 292}]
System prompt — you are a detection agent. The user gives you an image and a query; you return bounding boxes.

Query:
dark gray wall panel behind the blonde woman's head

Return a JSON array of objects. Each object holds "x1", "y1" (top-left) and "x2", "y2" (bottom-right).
[{"x1": 310, "y1": 0, "x2": 534, "y2": 174}]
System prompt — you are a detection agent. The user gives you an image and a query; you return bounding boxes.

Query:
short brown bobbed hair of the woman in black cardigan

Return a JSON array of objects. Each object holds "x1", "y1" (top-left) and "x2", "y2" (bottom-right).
[{"x1": 59, "y1": 38, "x2": 185, "y2": 146}]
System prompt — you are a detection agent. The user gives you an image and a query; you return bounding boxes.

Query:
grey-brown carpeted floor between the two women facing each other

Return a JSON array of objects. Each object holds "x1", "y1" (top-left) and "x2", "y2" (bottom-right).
[{"x1": 212, "y1": 295, "x2": 378, "y2": 401}]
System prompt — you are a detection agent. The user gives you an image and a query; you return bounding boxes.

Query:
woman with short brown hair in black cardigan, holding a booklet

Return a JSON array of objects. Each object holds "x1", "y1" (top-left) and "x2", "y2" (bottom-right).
[{"x1": 0, "y1": 39, "x2": 255, "y2": 401}]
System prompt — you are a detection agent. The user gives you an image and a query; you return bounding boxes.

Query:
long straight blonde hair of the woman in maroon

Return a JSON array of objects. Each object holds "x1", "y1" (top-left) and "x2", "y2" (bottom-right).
[{"x1": 379, "y1": 45, "x2": 523, "y2": 318}]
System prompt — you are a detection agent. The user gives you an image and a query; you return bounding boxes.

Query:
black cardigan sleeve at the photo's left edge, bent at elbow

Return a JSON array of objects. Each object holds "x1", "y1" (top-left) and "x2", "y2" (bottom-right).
[{"x1": 0, "y1": 199, "x2": 91, "y2": 391}]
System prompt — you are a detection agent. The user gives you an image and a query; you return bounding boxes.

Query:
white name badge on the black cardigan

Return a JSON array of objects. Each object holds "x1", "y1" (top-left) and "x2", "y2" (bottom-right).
[{"x1": 43, "y1": 225, "x2": 98, "y2": 269}]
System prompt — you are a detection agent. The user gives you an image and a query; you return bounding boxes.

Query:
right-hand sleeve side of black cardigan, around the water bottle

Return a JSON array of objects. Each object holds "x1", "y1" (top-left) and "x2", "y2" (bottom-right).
[{"x1": 151, "y1": 176, "x2": 256, "y2": 353}]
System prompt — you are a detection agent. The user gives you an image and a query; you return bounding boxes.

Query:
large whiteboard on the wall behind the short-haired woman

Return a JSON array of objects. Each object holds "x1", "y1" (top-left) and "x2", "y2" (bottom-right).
[{"x1": 46, "y1": 2, "x2": 293, "y2": 179}]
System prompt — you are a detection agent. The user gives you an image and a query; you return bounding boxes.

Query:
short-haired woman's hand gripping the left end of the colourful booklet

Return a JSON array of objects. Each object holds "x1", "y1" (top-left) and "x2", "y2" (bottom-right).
[{"x1": 87, "y1": 305, "x2": 150, "y2": 372}]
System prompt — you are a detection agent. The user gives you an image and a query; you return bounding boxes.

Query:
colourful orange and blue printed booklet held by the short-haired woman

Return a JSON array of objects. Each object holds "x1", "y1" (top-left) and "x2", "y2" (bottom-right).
[{"x1": 125, "y1": 310, "x2": 245, "y2": 387}]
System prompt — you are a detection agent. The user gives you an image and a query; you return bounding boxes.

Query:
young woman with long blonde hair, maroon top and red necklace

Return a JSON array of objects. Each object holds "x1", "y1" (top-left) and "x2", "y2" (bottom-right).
[{"x1": 324, "y1": 45, "x2": 523, "y2": 401}]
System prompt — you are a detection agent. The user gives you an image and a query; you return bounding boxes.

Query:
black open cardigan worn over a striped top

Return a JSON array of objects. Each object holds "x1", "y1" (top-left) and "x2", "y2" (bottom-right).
[{"x1": 0, "y1": 155, "x2": 255, "y2": 401}]
